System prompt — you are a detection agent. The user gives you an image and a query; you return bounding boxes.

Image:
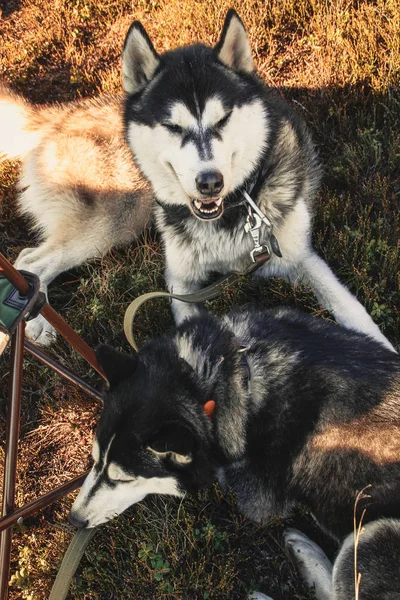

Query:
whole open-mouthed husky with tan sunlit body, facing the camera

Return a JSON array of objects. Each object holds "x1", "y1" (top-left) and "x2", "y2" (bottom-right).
[{"x1": 0, "y1": 10, "x2": 393, "y2": 350}]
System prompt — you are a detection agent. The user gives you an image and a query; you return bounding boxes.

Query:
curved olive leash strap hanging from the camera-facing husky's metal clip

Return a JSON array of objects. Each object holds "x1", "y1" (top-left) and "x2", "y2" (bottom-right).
[{"x1": 124, "y1": 251, "x2": 271, "y2": 352}]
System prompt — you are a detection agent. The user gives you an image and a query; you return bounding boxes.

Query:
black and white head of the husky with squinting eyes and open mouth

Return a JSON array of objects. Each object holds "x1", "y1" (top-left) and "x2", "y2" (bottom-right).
[{"x1": 123, "y1": 11, "x2": 268, "y2": 220}]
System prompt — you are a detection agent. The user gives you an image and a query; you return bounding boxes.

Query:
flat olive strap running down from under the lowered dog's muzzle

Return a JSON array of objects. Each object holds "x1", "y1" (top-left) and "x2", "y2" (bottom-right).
[{"x1": 49, "y1": 528, "x2": 96, "y2": 600}]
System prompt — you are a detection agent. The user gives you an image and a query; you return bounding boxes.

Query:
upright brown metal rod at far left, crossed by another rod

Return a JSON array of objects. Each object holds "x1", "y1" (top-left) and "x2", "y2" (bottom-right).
[{"x1": 0, "y1": 321, "x2": 25, "y2": 600}]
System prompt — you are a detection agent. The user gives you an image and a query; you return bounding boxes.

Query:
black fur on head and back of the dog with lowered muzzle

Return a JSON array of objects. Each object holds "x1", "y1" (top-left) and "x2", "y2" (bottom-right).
[{"x1": 99, "y1": 309, "x2": 400, "y2": 539}]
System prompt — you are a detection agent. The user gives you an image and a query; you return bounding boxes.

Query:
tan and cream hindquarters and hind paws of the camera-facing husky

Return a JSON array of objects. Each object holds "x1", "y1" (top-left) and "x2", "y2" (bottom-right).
[{"x1": 0, "y1": 85, "x2": 153, "y2": 345}]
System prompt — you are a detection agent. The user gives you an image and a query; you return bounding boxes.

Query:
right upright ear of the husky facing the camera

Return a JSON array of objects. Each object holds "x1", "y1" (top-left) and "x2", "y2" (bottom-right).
[{"x1": 215, "y1": 8, "x2": 255, "y2": 73}]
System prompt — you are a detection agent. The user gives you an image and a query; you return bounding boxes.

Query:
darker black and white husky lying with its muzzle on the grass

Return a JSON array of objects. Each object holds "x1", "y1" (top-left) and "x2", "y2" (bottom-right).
[{"x1": 71, "y1": 309, "x2": 400, "y2": 600}]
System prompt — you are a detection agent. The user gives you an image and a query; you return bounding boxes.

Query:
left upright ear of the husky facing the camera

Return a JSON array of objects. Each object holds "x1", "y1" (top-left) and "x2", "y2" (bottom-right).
[{"x1": 122, "y1": 21, "x2": 160, "y2": 94}]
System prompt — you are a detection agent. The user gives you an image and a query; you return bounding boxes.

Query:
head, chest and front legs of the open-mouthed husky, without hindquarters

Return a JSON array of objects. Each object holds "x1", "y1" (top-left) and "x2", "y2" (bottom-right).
[{"x1": 123, "y1": 10, "x2": 393, "y2": 349}]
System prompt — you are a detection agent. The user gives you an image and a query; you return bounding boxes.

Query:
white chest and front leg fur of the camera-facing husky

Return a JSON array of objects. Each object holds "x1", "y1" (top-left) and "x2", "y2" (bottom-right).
[{"x1": 164, "y1": 192, "x2": 395, "y2": 351}]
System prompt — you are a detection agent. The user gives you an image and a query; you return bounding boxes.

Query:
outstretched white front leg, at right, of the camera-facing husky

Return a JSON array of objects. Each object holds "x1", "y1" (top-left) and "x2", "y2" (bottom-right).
[{"x1": 296, "y1": 252, "x2": 396, "y2": 352}]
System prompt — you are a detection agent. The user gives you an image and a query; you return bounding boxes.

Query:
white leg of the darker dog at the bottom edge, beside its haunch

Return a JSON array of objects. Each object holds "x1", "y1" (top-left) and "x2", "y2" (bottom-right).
[{"x1": 284, "y1": 529, "x2": 332, "y2": 600}]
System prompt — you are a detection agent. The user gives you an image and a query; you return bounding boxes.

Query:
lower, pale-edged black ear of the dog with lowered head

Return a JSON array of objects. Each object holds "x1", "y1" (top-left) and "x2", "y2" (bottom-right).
[{"x1": 148, "y1": 423, "x2": 195, "y2": 465}]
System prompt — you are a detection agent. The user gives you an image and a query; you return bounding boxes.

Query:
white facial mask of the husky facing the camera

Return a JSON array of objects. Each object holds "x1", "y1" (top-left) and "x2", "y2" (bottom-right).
[{"x1": 128, "y1": 97, "x2": 268, "y2": 207}]
